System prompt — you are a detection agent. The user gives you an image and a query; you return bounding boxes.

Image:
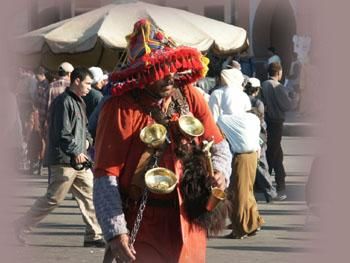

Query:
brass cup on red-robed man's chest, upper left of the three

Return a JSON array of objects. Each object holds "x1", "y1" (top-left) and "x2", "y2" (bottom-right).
[{"x1": 140, "y1": 123, "x2": 167, "y2": 148}]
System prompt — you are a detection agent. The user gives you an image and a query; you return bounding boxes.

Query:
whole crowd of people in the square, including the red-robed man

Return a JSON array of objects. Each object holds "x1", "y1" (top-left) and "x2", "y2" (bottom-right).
[{"x1": 14, "y1": 19, "x2": 294, "y2": 262}]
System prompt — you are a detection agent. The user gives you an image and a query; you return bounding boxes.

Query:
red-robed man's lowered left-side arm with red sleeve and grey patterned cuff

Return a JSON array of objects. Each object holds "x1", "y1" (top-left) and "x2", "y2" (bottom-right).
[{"x1": 94, "y1": 96, "x2": 139, "y2": 262}]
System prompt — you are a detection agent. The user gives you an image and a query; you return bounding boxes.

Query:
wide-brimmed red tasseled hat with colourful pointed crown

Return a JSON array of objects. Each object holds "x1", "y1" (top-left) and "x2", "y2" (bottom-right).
[{"x1": 110, "y1": 19, "x2": 209, "y2": 96}]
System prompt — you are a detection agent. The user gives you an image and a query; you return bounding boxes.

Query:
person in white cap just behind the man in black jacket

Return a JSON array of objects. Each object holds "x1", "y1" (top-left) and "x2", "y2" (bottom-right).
[{"x1": 83, "y1": 67, "x2": 105, "y2": 118}]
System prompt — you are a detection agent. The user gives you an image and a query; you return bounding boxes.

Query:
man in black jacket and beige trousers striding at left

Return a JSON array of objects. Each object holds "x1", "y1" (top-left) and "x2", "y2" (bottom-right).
[{"x1": 15, "y1": 68, "x2": 104, "y2": 247}]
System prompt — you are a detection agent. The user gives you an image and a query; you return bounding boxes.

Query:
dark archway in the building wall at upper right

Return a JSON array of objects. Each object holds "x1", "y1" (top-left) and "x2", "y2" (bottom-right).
[{"x1": 252, "y1": 0, "x2": 296, "y2": 79}]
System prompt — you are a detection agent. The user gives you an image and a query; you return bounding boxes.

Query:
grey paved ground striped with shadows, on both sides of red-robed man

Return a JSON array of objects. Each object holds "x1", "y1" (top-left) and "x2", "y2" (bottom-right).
[{"x1": 9, "y1": 137, "x2": 317, "y2": 263}]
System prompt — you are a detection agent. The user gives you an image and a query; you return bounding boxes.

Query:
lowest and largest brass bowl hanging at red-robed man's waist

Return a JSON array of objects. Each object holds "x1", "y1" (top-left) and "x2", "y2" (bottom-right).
[{"x1": 145, "y1": 167, "x2": 177, "y2": 194}]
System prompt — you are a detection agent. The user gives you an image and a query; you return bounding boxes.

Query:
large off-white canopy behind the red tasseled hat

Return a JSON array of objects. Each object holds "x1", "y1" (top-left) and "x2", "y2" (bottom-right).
[{"x1": 15, "y1": 2, "x2": 248, "y2": 69}]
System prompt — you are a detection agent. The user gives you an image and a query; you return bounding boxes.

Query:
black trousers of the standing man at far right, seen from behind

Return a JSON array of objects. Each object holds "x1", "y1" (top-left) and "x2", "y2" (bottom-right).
[{"x1": 266, "y1": 120, "x2": 286, "y2": 191}]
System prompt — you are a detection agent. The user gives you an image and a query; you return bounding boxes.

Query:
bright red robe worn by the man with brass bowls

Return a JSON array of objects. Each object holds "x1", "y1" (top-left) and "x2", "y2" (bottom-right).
[{"x1": 95, "y1": 86, "x2": 223, "y2": 263}]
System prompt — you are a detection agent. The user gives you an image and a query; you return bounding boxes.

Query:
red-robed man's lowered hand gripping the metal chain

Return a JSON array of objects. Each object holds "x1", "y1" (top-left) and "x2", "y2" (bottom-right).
[{"x1": 110, "y1": 234, "x2": 136, "y2": 262}]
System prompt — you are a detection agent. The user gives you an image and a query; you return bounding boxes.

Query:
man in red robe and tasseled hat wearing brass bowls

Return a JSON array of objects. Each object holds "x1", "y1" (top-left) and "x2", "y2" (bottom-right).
[{"x1": 94, "y1": 19, "x2": 232, "y2": 262}]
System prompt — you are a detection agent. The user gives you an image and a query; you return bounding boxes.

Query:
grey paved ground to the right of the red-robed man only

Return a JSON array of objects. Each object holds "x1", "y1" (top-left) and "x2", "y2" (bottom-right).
[{"x1": 207, "y1": 137, "x2": 318, "y2": 263}]
